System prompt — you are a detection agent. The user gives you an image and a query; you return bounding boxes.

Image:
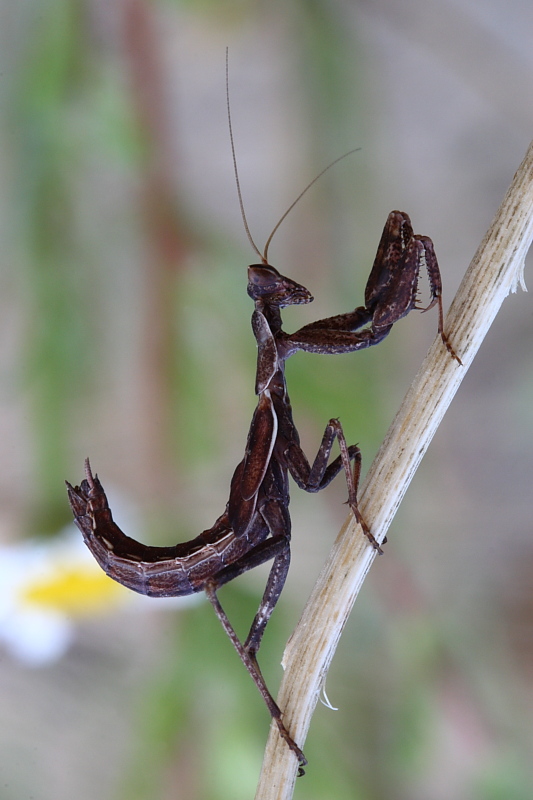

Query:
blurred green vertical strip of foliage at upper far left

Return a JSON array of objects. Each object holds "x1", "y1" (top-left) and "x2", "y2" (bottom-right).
[{"x1": 11, "y1": 0, "x2": 94, "y2": 532}]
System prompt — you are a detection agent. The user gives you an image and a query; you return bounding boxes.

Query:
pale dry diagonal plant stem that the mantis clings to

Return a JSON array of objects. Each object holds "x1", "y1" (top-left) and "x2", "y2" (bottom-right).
[{"x1": 256, "y1": 143, "x2": 533, "y2": 800}]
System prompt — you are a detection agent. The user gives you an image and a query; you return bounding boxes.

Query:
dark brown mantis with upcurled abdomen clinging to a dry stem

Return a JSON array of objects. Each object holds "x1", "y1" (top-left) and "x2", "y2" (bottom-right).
[{"x1": 67, "y1": 83, "x2": 460, "y2": 774}]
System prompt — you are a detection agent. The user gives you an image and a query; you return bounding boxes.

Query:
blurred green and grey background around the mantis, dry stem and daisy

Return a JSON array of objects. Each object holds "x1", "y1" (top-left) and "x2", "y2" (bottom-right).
[{"x1": 0, "y1": 0, "x2": 533, "y2": 800}]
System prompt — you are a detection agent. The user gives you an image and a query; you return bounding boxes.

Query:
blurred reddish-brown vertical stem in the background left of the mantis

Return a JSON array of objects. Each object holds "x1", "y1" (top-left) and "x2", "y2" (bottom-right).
[{"x1": 121, "y1": 0, "x2": 191, "y2": 504}]
